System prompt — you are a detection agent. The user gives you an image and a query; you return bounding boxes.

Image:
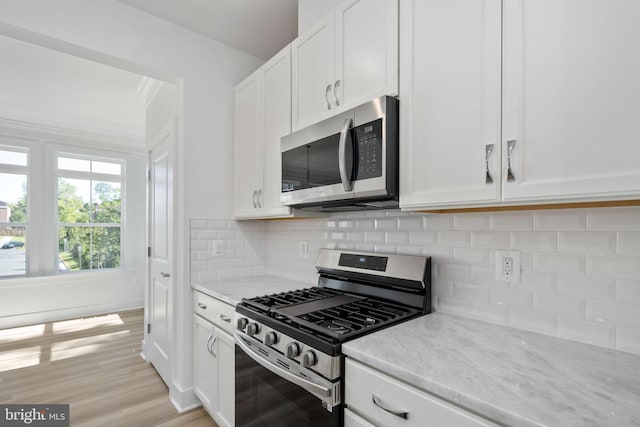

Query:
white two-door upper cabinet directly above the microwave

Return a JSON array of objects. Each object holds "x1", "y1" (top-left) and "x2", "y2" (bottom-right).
[{"x1": 292, "y1": 0, "x2": 398, "y2": 131}]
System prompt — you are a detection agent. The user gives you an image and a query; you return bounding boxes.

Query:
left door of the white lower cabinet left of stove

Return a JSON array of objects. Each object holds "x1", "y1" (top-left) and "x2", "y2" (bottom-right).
[{"x1": 193, "y1": 316, "x2": 218, "y2": 412}]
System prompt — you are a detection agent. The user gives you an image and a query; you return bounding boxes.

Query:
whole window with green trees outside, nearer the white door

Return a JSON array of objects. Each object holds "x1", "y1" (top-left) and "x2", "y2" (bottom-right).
[{"x1": 57, "y1": 155, "x2": 124, "y2": 272}]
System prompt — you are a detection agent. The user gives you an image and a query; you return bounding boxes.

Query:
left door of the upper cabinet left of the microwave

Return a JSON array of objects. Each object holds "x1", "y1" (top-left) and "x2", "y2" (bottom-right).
[{"x1": 234, "y1": 73, "x2": 262, "y2": 217}]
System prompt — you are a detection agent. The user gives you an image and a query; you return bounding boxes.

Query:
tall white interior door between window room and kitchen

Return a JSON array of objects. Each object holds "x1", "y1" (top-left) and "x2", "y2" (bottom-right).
[{"x1": 147, "y1": 124, "x2": 175, "y2": 384}]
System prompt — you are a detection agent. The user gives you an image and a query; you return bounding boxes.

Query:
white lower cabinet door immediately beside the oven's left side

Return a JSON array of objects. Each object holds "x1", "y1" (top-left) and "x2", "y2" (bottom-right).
[{"x1": 215, "y1": 328, "x2": 236, "y2": 426}]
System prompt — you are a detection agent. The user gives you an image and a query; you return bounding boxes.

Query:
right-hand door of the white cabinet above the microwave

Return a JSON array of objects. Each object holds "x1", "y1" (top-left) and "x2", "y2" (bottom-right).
[{"x1": 334, "y1": 0, "x2": 398, "y2": 109}]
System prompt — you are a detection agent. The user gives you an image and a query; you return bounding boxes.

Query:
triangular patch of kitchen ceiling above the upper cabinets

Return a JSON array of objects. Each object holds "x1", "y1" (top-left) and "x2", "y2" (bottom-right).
[{"x1": 119, "y1": 0, "x2": 298, "y2": 60}]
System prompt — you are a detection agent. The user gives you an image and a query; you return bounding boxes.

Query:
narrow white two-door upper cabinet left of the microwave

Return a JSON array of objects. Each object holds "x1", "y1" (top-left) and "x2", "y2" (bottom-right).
[{"x1": 235, "y1": 46, "x2": 293, "y2": 218}]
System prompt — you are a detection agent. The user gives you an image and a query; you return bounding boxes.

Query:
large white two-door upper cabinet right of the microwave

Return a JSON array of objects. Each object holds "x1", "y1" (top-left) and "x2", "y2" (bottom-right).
[{"x1": 400, "y1": 0, "x2": 640, "y2": 209}]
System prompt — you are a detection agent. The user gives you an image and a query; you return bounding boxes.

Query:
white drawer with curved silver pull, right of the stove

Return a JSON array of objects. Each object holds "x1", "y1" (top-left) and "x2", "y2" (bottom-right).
[{"x1": 345, "y1": 359, "x2": 496, "y2": 427}]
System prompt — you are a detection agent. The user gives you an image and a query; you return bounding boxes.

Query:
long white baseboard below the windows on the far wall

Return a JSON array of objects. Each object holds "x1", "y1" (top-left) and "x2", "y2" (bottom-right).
[{"x1": 0, "y1": 300, "x2": 144, "y2": 329}]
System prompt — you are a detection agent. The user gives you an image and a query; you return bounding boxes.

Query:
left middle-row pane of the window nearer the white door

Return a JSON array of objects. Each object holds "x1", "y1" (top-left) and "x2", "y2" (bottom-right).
[{"x1": 58, "y1": 178, "x2": 91, "y2": 223}]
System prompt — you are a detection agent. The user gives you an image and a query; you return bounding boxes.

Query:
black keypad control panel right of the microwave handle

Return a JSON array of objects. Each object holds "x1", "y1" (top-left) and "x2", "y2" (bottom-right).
[{"x1": 354, "y1": 119, "x2": 384, "y2": 180}]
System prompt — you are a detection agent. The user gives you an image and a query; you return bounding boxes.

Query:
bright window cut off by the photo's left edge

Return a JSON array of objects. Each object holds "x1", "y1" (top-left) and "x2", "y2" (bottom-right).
[{"x1": 0, "y1": 146, "x2": 29, "y2": 277}]
